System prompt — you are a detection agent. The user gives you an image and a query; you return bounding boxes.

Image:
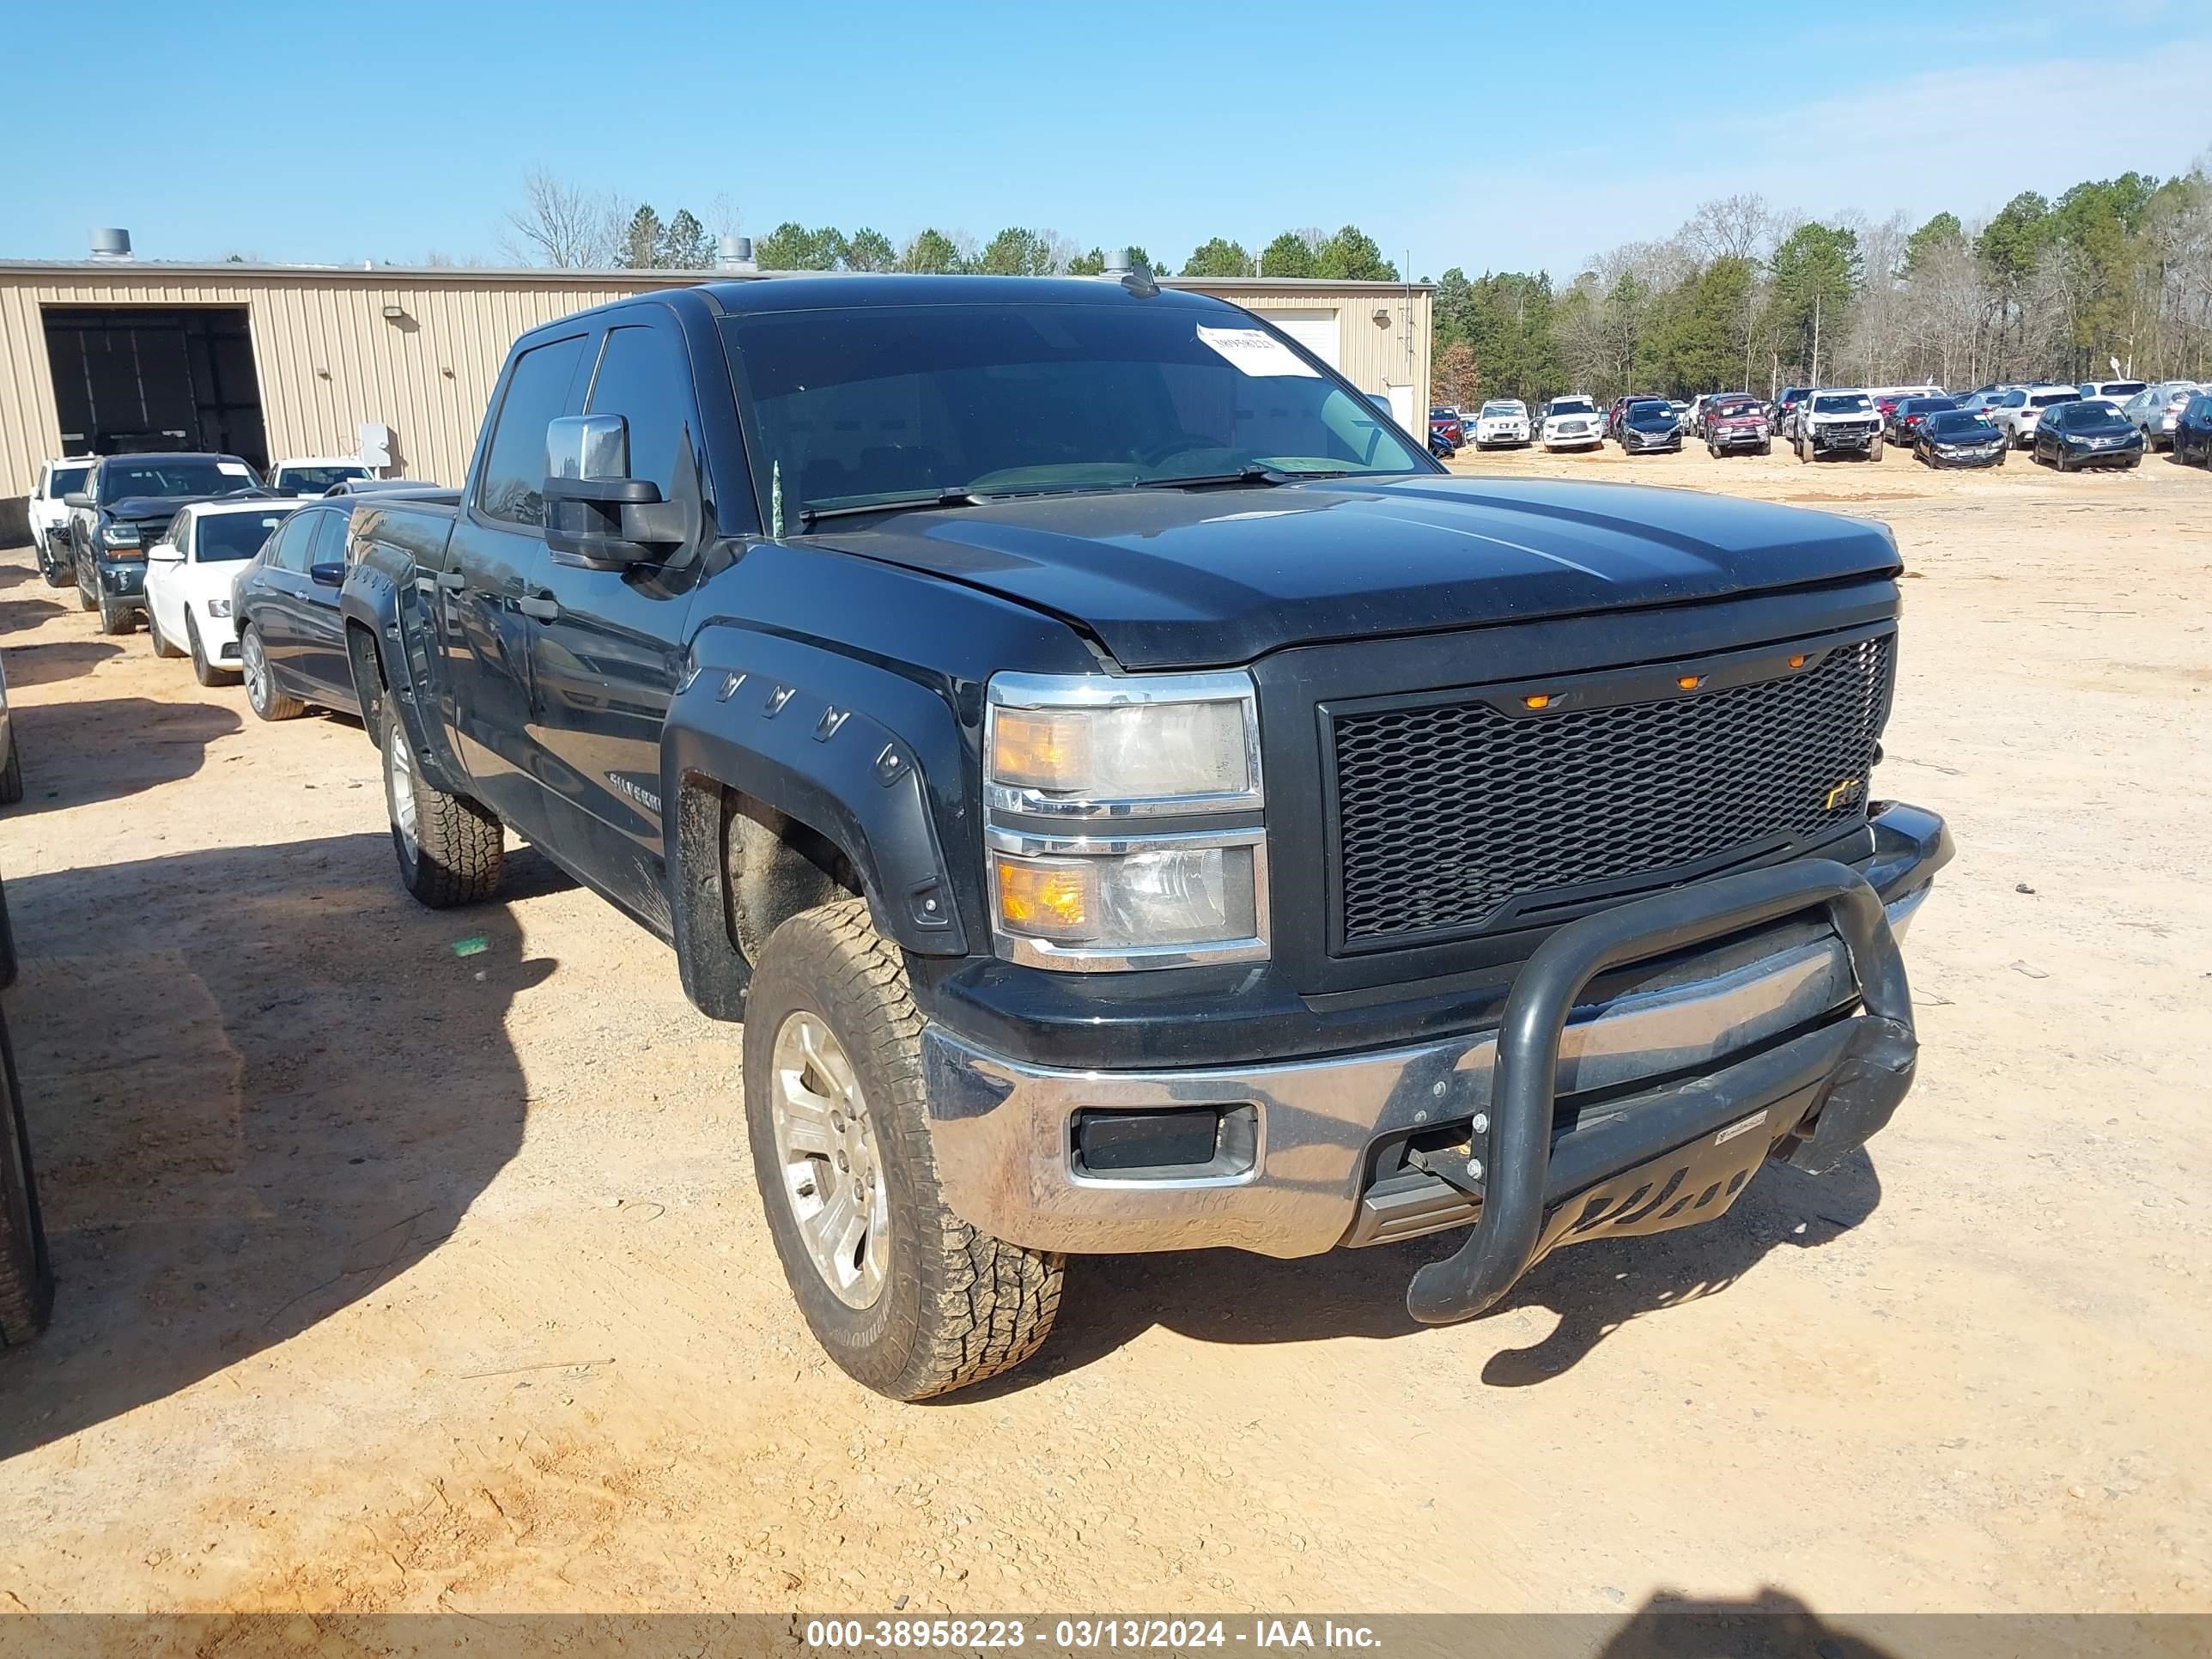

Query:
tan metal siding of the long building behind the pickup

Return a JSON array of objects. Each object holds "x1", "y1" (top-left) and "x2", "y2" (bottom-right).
[{"x1": 0, "y1": 265, "x2": 1429, "y2": 498}]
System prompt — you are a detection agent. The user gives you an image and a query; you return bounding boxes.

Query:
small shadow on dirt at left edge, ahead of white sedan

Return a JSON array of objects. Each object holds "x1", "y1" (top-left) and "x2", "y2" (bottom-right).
[{"x1": 7, "y1": 690, "x2": 243, "y2": 818}]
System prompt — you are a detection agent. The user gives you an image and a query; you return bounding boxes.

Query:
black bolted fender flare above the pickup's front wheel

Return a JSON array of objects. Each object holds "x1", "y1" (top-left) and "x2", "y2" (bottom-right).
[{"x1": 661, "y1": 623, "x2": 982, "y2": 1018}]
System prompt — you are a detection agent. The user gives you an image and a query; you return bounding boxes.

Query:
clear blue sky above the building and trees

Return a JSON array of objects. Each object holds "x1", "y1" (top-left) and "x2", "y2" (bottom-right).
[{"x1": 0, "y1": 0, "x2": 2212, "y2": 274}]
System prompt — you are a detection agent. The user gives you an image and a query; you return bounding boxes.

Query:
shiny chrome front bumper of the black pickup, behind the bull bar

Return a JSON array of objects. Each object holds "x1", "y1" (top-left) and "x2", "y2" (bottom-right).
[{"x1": 922, "y1": 883, "x2": 1929, "y2": 1256}]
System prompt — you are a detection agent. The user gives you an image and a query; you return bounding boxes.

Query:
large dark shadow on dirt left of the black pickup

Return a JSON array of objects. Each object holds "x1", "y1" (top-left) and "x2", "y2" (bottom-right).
[{"x1": 0, "y1": 832, "x2": 566, "y2": 1460}]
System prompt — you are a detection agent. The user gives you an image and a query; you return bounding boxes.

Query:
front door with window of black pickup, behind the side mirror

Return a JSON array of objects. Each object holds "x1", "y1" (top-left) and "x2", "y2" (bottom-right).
[{"x1": 529, "y1": 318, "x2": 703, "y2": 915}]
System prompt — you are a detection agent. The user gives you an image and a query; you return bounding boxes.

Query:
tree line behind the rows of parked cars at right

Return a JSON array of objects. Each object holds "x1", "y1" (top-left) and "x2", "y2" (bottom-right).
[{"x1": 1433, "y1": 161, "x2": 2212, "y2": 403}]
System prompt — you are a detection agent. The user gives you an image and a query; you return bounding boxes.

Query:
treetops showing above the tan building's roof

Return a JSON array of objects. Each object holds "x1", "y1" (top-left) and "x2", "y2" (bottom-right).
[{"x1": 504, "y1": 173, "x2": 1398, "y2": 281}]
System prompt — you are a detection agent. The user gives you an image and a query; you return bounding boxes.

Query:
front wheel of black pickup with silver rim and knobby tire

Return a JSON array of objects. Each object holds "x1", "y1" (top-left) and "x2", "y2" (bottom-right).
[{"x1": 745, "y1": 898, "x2": 1066, "y2": 1401}]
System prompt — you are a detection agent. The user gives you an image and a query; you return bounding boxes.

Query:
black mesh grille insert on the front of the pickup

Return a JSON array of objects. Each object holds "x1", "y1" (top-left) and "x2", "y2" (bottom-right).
[{"x1": 1332, "y1": 635, "x2": 1891, "y2": 945}]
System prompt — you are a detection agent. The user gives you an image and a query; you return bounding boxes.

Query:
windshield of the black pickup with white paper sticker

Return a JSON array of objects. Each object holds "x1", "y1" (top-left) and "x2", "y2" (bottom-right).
[{"x1": 723, "y1": 303, "x2": 1433, "y2": 522}]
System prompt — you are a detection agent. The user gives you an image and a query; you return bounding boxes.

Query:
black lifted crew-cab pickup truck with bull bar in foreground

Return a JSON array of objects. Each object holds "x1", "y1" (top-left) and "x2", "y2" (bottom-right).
[{"x1": 343, "y1": 272, "x2": 1951, "y2": 1398}]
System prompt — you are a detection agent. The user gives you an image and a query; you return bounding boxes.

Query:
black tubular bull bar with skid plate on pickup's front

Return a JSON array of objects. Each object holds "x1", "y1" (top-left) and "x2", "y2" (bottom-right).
[{"x1": 1405, "y1": 858, "x2": 1920, "y2": 1325}]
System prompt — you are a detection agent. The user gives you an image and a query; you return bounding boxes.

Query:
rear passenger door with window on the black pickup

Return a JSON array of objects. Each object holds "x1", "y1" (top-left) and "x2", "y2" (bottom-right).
[{"x1": 435, "y1": 327, "x2": 595, "y2": 834}]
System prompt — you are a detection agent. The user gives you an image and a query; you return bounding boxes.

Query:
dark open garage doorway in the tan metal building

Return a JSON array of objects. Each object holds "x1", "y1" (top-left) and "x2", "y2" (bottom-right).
[{"x1": 45, "y1": 305, "x2": 270, "y2": 467}]
